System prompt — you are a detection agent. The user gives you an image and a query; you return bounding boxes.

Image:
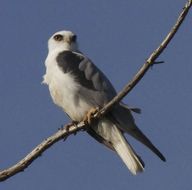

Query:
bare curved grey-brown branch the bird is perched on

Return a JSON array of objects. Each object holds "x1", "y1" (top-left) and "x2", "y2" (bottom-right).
[{"x1": 0, "y1": 0, "x2": 192, "y2": 181}]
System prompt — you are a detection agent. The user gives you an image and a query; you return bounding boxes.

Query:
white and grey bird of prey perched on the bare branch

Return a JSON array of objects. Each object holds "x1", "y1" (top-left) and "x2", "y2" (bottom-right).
[{"x1": 43, "y1": 30, "x2": 166, "y2": 175}]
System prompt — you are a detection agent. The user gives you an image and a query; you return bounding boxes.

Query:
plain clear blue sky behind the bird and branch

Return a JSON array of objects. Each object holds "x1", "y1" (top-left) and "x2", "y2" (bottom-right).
[{"x1": 0, "y1": 0, "x2": 192, "y2": 190}]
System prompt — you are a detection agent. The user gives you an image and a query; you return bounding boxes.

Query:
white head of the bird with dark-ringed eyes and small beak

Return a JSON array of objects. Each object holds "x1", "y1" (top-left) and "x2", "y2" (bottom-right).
[{"x1": 48, "y1": 30, "x2": 78, "y2": 51}]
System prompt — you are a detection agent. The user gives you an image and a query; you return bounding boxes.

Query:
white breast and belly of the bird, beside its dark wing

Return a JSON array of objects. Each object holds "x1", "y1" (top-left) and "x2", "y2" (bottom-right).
[{"x1": 44, "y1": 61, "x2": 91, "y2": 121}]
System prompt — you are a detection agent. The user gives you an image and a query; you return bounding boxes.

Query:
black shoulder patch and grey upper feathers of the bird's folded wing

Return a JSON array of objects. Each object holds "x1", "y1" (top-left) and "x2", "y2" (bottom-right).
[{"x1": 56, "y1": 51, "x2": 116, "y2": 94}]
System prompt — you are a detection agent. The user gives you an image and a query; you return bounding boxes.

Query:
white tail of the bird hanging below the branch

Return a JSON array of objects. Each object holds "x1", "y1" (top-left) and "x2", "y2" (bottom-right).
[{"x1": 93, "y1": 118, "x2": 144, "y2": 175}]
